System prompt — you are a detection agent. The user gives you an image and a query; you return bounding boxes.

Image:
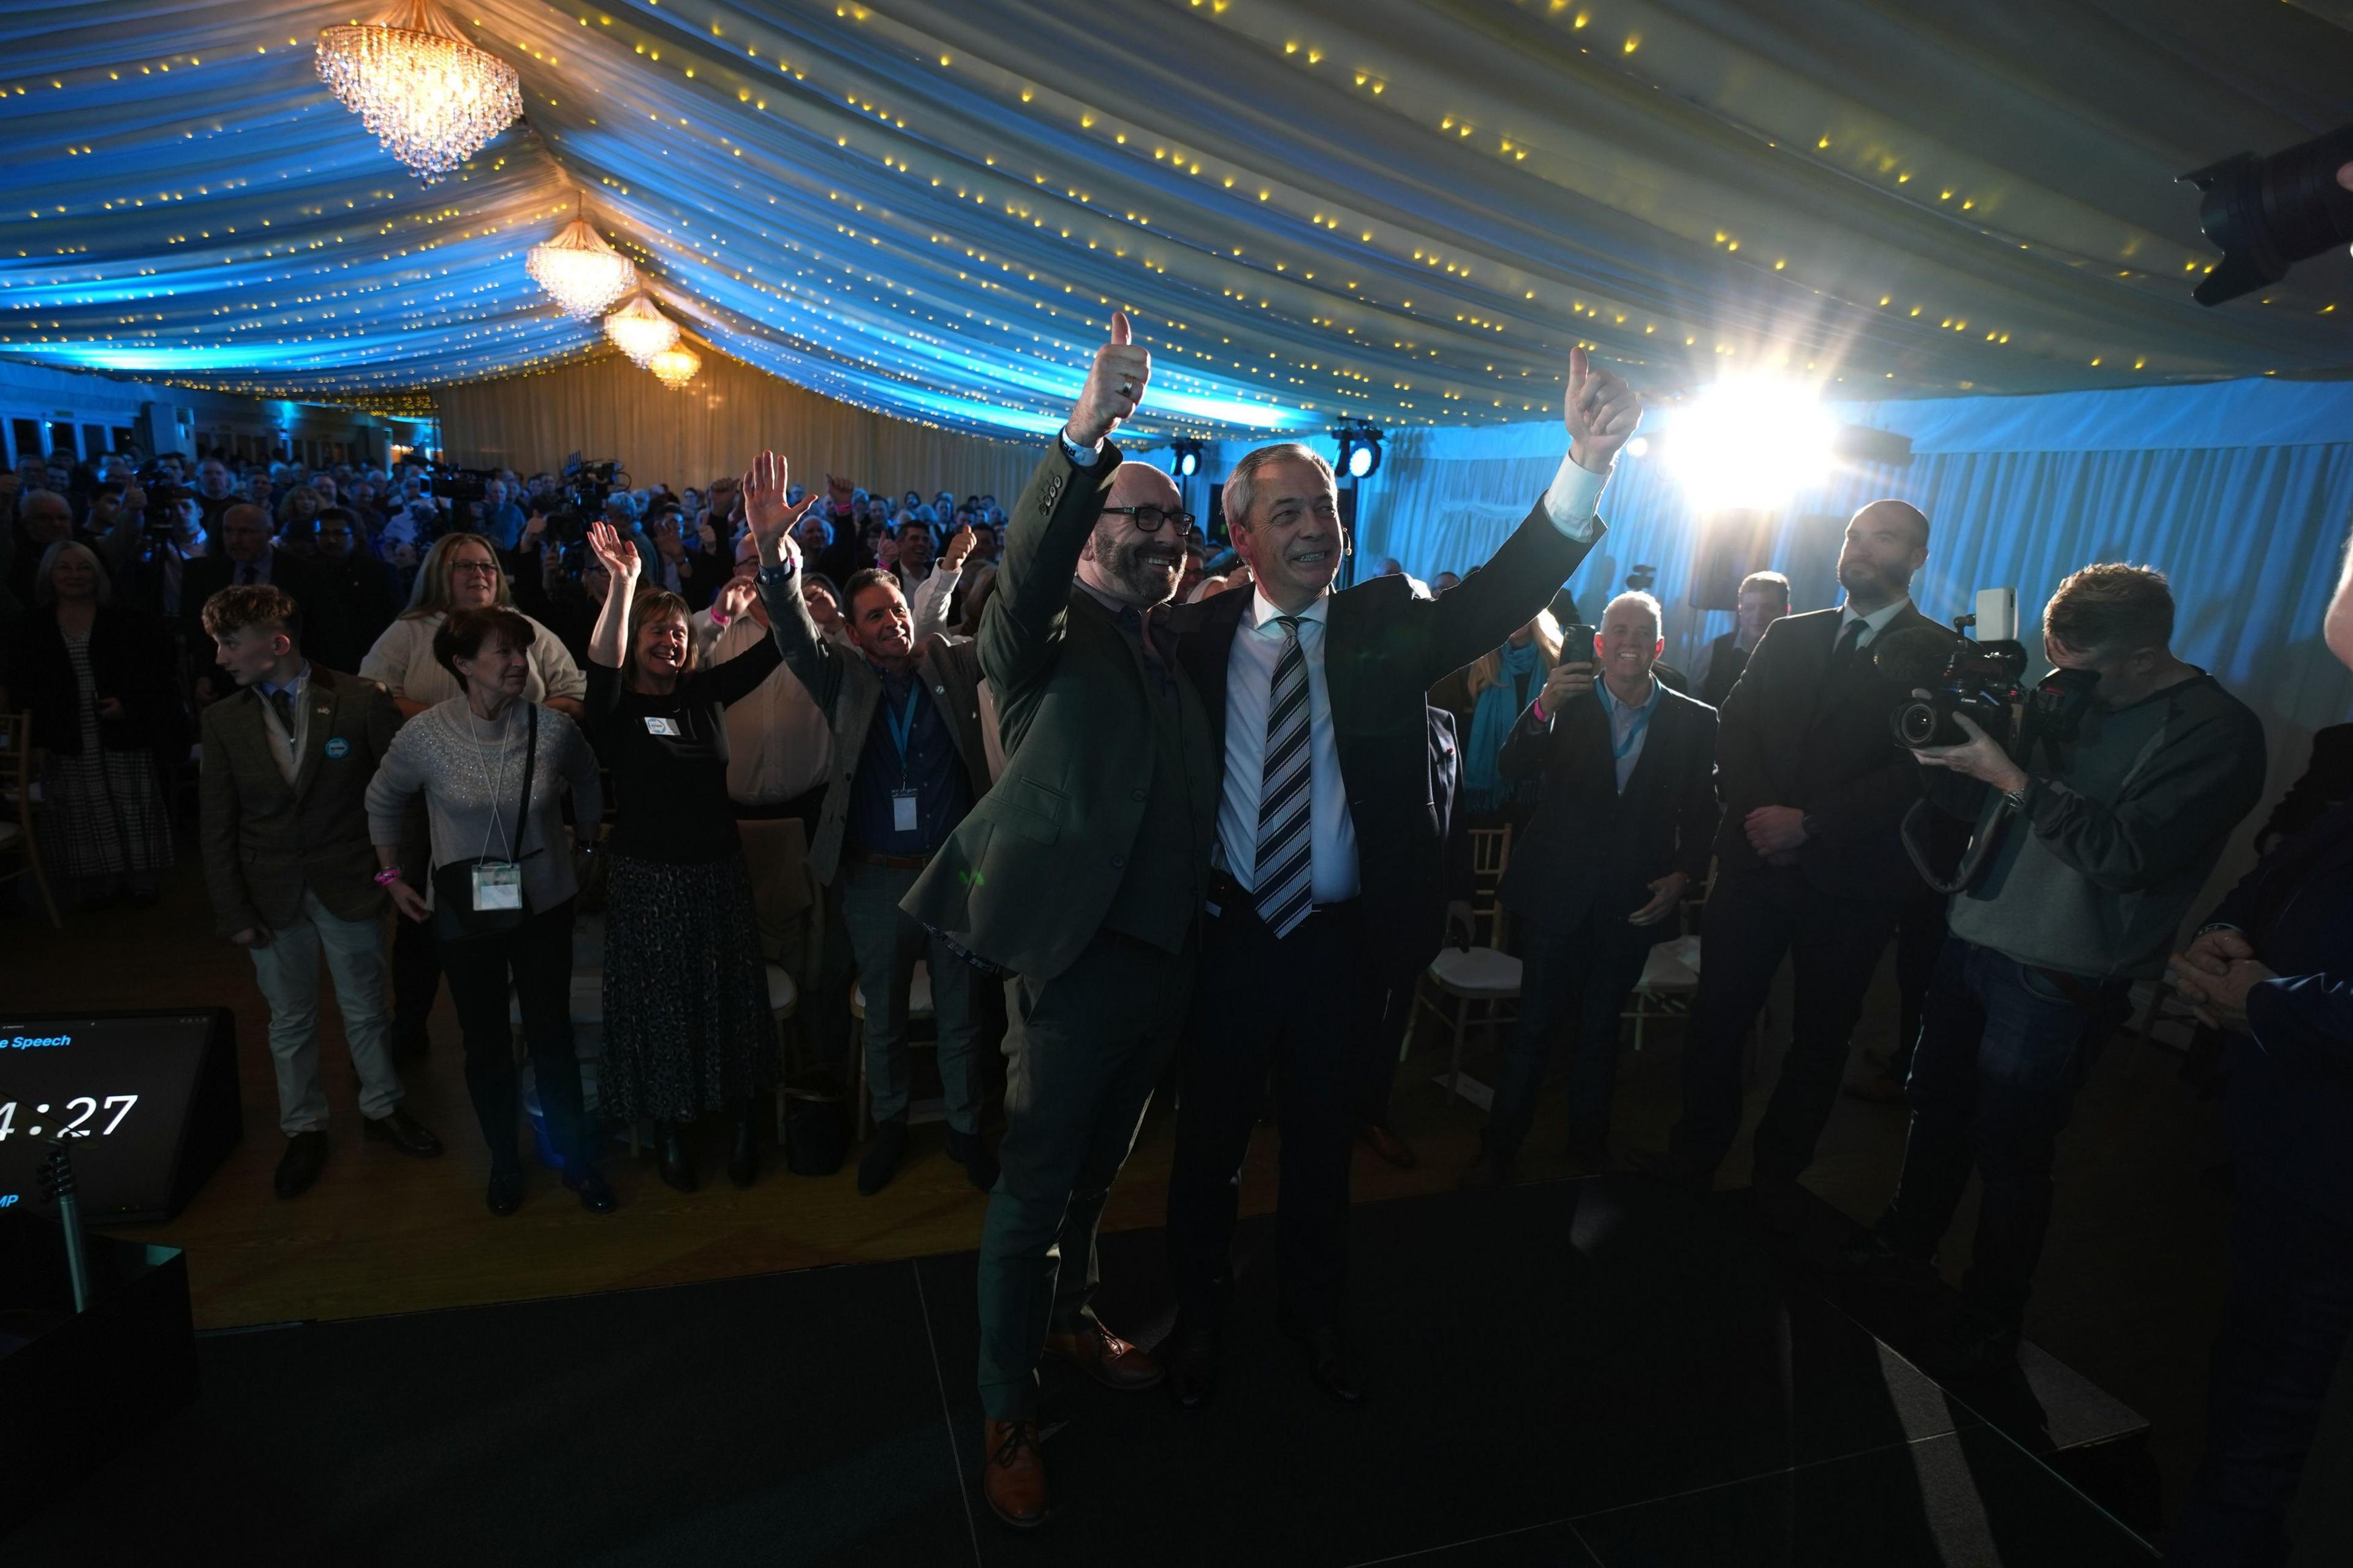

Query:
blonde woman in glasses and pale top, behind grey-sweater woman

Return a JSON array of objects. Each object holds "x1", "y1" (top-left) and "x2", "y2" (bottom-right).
[{"x1": 360, "y1": 532, "x2": 596, "y2": 1057}]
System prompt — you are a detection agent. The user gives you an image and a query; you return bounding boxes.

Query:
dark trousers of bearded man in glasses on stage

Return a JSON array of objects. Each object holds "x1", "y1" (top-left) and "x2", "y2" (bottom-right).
[{"x1": 981, "y1": 933, "x2": 1193, "y2": 1420}]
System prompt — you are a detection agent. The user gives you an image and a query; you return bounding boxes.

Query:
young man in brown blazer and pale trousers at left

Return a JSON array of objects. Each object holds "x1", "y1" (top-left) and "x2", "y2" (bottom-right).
[{"x1": 200, "y1": 584, "x2": 442, "y2": 1199}]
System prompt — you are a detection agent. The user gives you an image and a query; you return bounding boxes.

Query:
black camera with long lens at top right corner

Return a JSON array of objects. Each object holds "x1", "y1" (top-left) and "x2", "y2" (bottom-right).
[{"x1": 2181, "y1": 125, "x2": 2353, "y2": 306}]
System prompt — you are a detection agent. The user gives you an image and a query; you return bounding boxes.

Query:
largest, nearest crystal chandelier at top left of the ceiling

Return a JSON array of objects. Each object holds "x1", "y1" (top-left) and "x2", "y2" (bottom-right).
[{"x1": 317, "y1": 0, "x2": 522, "y2": 186}]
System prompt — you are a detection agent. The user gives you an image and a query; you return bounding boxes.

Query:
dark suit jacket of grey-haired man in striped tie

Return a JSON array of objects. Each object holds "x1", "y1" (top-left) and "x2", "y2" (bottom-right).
[{"x1": 1172, "y1": 497, "x2": 1605, "y2": 975}]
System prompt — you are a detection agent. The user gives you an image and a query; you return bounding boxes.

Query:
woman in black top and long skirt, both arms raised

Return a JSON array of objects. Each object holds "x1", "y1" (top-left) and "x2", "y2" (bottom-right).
[{"x1": 588, "y1": 520, "x2": 784, "y2": 1191}]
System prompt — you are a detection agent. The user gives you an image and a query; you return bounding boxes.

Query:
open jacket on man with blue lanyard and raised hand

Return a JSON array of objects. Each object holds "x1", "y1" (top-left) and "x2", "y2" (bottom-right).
[{"x1": 760, "y1": 572, "x2": 988, "y2": 885}]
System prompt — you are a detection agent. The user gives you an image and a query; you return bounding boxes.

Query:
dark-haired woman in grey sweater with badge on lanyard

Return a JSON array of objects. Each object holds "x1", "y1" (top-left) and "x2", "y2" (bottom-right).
[{"x1": 367, "y1": 610, "x2": 614, "y2": 1215}]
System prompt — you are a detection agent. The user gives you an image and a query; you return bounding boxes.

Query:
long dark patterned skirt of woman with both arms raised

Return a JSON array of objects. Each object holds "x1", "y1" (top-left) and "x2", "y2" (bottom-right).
[{"x1": 600, "y1": 855, "x2": 776, "y2": 1121}]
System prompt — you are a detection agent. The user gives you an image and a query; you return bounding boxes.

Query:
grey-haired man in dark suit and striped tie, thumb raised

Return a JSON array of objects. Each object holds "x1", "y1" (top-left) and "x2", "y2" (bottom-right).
[{"x1": 1169, "y1": 349, "x2": 1642, "y2": 1408}]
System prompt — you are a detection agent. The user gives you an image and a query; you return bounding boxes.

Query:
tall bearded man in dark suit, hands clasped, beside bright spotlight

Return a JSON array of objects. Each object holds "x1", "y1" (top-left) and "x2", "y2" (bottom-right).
[{"x1": 1645, "y1": 501, "x2": 1934, "y2": 1227}]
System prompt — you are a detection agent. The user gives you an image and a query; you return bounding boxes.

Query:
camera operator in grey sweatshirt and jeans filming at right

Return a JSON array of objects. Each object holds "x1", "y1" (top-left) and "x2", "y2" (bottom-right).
[{"x1": 1847, "y1": 565, "x2": 2264, "y2": 1375}]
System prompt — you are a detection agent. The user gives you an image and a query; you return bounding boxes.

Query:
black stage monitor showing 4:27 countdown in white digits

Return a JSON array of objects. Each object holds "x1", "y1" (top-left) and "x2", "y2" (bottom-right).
[{"x1": 0, "y1": 1008, "x2": 238, "y2": 1219}]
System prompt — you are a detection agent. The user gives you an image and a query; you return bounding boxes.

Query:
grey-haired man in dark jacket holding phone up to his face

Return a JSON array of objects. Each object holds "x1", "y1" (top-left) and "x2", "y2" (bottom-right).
[{"x1": 1461, "y1": 593, "x2": 1718, "y2": 1187}]
